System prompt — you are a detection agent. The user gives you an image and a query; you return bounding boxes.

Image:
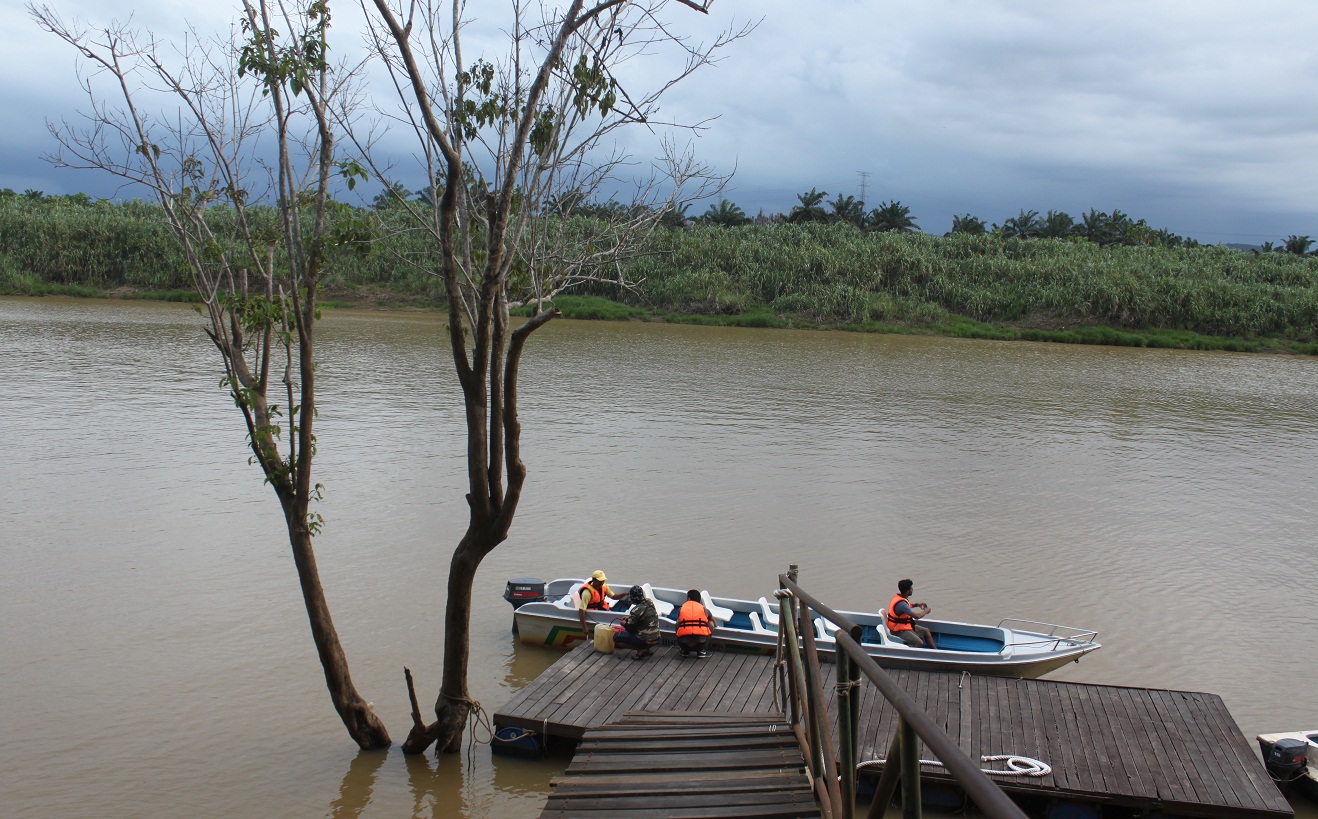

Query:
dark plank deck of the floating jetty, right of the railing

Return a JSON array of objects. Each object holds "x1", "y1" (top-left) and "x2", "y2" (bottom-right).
[{"x1": 848, "y1": 666, "x2": 1293, "y2": 819}]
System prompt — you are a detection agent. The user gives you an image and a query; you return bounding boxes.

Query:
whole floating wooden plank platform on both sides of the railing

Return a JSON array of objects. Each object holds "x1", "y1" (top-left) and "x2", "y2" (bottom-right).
[{"x1": 493, "y1": 645, "x2": 1293, "y2": 819}]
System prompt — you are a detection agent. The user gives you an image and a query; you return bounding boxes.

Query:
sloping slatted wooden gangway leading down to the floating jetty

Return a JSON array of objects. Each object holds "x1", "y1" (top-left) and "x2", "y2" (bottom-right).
[{"x1": 540, "y1": 712, "x2": 820, "y2": 819}]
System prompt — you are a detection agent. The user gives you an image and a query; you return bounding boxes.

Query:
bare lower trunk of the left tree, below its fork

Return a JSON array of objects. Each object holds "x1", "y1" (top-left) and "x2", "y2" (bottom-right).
[{"x1": 289, "y1": 520, "x2": 390, "y2": 750}]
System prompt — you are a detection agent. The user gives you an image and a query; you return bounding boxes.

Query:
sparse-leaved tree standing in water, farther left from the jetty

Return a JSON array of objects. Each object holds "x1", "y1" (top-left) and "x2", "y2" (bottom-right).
[{"x1": 28, "y1": 0, "x2": 389, "y2": 748}]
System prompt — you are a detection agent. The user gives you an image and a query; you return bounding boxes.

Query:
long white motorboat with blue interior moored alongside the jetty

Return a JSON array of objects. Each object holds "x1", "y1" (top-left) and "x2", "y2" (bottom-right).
[{"x1": 503, "y1": 578, "x2": 1099, "y2": 677}]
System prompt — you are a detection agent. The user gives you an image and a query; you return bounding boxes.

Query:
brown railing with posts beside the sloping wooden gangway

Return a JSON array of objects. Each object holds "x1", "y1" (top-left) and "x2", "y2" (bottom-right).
[{"x1": 778, "y1": 564, "x2": 1025, "y2": 819}]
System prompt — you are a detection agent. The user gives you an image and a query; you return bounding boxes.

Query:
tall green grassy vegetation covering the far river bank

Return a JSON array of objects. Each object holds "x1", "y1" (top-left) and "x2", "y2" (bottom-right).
[{"x1": 0, "y1": 198, "x2": 1318, "y2": 355}]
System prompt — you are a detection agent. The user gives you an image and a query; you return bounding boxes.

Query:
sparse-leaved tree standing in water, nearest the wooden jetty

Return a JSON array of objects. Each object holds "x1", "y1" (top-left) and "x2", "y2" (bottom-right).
[{"x1": 361, "y1": 0, "x2": 750, "y2": 753}]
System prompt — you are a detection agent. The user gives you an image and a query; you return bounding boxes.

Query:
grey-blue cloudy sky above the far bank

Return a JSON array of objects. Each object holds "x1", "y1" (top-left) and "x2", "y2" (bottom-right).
[{"x1": 0, "y1": 0, "x2": 1318, "y2": 244}]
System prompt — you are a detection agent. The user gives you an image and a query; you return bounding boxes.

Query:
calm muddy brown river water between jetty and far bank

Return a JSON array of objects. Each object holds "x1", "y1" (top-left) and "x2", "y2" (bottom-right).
[{"x1": 0, "y1": 298, "x2": 1318, "y2": 818}]
